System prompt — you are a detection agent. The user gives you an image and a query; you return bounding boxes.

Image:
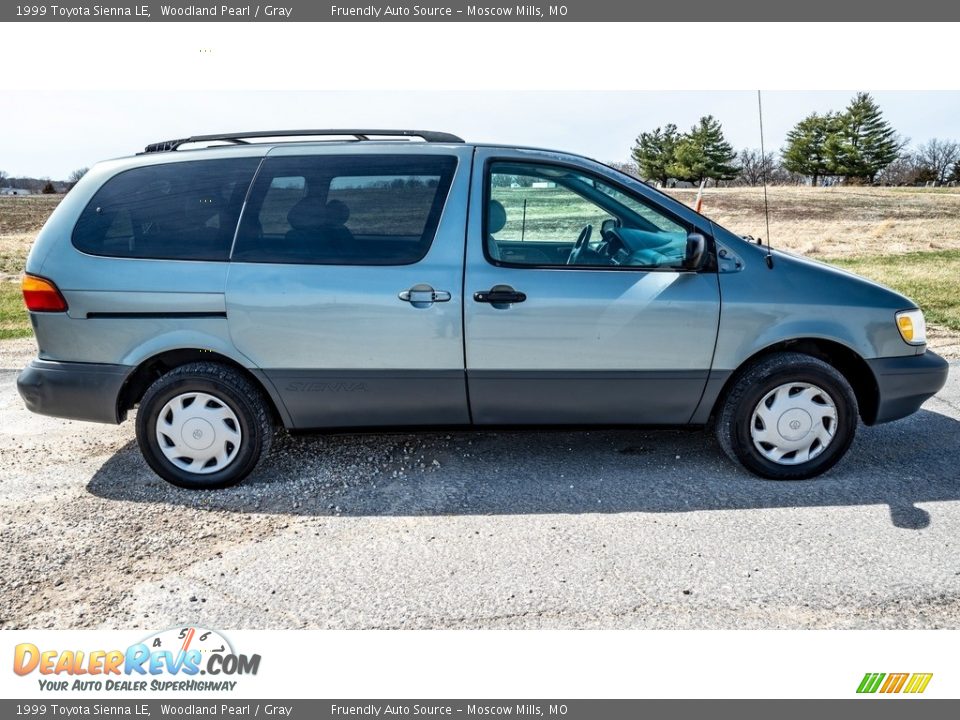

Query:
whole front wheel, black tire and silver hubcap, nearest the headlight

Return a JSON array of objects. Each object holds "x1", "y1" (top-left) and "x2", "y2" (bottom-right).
[{"x1": 716, "y1": 353, "x2": 857, "y2": 480}]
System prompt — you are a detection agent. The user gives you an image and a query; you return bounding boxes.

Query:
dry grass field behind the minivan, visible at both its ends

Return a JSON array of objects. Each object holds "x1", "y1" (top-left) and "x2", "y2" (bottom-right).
[{"x1": 0, "y1": 187, "x2": 960, "y2": 358}]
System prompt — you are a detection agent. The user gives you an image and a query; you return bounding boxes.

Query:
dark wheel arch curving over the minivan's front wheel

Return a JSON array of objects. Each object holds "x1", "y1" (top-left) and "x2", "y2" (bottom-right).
[{"x1": 698, "y1": 337, "x2": 880, "y2": 425}]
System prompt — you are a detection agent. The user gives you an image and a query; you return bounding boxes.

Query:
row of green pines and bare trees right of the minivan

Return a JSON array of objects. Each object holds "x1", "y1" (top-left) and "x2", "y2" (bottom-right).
[{"x1": 614, "y1": 93, "x2": 960, "y2": 187}]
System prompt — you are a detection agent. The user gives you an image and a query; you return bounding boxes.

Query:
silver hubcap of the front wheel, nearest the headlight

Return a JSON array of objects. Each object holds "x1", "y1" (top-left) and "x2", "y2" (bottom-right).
[{"x1": 750, "y1": 382, "x2": 837, "y2": 465}]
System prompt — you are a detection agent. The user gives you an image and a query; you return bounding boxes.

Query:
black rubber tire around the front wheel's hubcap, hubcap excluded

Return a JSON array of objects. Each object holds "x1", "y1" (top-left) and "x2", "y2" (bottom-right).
[{"x1": 715, "y1": 352, "x2": 858, "y2": 480}]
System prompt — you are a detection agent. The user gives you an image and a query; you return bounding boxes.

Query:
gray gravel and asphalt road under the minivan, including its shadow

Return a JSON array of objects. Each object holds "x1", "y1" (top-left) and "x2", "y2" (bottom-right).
[{"x1": 0, "y1": 341, "x2": 960, "y2": 629}]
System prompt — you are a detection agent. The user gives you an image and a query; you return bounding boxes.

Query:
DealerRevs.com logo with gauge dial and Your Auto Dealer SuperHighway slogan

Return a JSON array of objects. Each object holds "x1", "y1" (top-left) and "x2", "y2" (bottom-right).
[{"x1": 13, "y1": 626, "x2": 260, "y2": 692}]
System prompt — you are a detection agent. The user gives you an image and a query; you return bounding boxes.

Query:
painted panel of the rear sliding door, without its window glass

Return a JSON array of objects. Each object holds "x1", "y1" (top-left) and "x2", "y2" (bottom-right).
[{"x1": 225, "y1": 143, "x2": 472, "y2": 428}]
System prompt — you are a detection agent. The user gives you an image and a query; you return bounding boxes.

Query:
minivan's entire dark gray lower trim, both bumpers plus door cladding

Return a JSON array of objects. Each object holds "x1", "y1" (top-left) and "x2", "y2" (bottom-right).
[{"x1": 17, "y1": 351, "x2": 948, "y2": 430}]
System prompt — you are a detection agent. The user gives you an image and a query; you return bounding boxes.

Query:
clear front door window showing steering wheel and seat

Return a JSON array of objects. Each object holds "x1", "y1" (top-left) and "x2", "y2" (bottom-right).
[{"x1": 485, "y1": 161, "x2": 689, "y2": 269}]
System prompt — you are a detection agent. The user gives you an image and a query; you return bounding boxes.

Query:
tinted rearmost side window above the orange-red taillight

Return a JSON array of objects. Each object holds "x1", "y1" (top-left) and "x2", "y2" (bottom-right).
[{"x1": 73, "y1": 158, "x2": 260, "y2": 260}]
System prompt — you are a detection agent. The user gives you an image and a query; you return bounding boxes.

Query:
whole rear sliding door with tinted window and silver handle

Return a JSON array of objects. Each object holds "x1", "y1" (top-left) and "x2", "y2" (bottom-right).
[{"x1": 226, "y1": 144, "x2": 471, "y2": 428}]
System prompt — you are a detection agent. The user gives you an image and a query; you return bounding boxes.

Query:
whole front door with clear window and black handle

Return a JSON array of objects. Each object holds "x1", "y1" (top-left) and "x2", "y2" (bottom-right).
[{"x1": 464, "y1": 148, "x2": 720, "y2": 424}]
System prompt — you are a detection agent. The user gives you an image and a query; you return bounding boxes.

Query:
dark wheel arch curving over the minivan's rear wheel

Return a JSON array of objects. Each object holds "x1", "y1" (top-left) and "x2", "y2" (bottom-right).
[{"x1": 117, "y1": 348, "x2": 290, "y2": 427}]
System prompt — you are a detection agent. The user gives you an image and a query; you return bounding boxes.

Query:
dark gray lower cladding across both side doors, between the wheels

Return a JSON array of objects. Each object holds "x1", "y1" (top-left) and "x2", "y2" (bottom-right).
[{"x1": 266, "y1": 369, "x2": 708, "y2": 430}]
